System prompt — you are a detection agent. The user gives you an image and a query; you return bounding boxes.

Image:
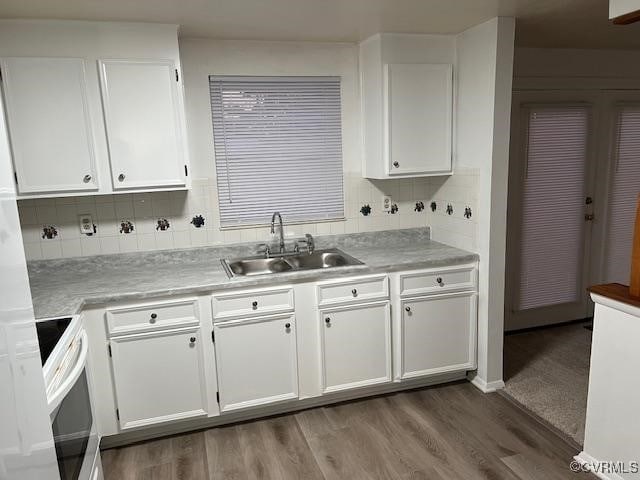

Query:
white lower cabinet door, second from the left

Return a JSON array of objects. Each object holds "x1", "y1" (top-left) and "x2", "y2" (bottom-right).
[{"x1": 213, "y1": 314, "x2": 298, "y2": 412}]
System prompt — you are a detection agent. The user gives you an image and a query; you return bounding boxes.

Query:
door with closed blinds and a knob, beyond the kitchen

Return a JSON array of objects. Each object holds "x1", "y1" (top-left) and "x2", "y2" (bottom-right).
[{"x1": 506, "y1": 93, "x2": 597, "y2": 330}]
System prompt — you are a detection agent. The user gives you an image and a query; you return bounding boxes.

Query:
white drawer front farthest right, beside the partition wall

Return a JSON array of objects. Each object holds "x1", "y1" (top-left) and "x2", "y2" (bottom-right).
[{"x1": 400, "y1": 266, "x2": 476, "y2": 295}]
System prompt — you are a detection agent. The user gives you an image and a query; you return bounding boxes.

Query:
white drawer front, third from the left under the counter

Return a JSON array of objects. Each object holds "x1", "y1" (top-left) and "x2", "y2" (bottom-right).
[{"x1": 317, "y1": 275, "x2": 389, "y2": 305}]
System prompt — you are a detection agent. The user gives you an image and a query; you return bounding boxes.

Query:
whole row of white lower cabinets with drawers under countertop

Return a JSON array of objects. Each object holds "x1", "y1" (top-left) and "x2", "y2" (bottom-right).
[{"x1": 94, "y1": 264, "x2": 477, "y2": 434}]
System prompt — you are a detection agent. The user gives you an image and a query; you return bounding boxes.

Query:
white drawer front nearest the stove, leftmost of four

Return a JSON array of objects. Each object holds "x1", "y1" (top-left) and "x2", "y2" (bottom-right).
[{"x1": 107, "y1": 298, "x2": 200, "y2": 335}]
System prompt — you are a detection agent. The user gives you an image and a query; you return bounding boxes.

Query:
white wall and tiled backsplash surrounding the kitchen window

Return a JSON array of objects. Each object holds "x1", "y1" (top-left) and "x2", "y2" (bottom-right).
[{"x1": 20, "y1": 34, "x2": 477, "y2": 259}]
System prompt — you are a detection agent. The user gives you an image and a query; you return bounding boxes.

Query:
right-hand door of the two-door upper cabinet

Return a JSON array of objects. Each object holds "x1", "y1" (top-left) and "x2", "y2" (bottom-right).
[{"x1": 100, "y1": 60, "x2": 186, "y2": 190}]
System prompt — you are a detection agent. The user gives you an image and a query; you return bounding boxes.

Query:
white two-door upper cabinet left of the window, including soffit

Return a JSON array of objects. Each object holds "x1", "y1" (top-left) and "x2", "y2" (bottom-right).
[{"x1": 0, "y1": 20, "x2": 190, "y2": 198}]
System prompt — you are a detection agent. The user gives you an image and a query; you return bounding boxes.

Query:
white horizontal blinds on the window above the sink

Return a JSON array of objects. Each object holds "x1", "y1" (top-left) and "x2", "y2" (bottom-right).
[{"x1": 209, "y1": 76, "x2": 344, "y2": 227}]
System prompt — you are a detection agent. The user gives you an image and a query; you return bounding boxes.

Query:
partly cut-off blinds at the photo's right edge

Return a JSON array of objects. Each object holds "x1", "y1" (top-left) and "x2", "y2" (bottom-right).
[{"x1": 604, "y1": 105, "x2": 640, "y2": 285}]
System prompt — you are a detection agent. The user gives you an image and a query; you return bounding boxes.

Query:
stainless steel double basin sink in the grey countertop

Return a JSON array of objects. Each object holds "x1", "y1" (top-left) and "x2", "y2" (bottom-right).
[{"x1": 222, "y1": 248, "x2": 364, "y2": 278}]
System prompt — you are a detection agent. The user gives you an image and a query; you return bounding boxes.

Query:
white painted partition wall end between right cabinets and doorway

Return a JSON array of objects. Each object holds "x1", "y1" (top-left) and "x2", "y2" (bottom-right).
[{"x1": 448, "y1": 18, "x2": 515, "y2": 390}]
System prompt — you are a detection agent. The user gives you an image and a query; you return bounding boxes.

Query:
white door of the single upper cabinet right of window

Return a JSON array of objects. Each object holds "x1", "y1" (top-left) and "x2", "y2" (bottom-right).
[{"x1": 384, "y1": 64, "x2": 453, "y2": 175}]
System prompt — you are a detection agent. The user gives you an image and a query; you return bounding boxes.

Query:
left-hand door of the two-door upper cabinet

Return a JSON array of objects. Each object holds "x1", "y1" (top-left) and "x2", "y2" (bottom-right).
[{"x1": 1, "y1": 58, "x2": 98, "y2": 195}]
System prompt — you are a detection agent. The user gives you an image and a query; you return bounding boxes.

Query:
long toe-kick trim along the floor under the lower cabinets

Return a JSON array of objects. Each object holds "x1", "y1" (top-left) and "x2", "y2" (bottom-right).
[{"x1": 100, "y1": 372, "x2": 466, "y2": 450}]
